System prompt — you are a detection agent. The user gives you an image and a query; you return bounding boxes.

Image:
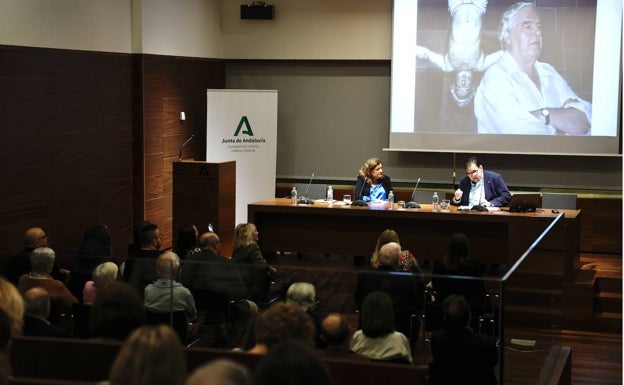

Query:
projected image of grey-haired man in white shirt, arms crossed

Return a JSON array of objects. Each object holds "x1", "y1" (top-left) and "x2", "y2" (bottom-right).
[{"x1": 474, "y1": 2, "x2": 592, "y2": 135}]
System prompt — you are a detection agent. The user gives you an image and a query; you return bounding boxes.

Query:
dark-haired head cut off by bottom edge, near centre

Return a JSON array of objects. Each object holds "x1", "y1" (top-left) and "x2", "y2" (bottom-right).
[{"x1": 254, "y1": 340, "x2": 332, "y2": 385}]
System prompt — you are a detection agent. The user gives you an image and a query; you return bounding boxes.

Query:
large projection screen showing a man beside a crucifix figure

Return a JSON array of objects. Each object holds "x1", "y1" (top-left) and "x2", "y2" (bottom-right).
[{"x1": 386, "y1": 0, "x2": 622, "y2": 156}]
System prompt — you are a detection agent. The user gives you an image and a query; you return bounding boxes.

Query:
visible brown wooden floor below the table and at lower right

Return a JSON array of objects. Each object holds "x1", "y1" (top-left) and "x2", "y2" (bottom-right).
[{"x1": 272, "y1": 250, "x2": 622, "y2": 385}]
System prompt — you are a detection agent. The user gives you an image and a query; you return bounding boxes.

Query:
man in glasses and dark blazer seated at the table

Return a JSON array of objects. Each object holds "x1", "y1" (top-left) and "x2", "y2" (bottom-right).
[{"x1": 451, "y1": 156, "x2": 511, "y2": 207}]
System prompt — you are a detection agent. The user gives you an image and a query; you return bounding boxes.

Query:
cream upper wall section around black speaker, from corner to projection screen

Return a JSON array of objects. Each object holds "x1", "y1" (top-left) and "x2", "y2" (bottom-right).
[{"x1": 222, "y1": 0, "x2": 392, "y2": 60}]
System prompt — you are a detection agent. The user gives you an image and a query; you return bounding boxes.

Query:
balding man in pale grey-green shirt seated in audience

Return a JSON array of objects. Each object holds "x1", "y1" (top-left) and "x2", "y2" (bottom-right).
[{"x1": 143, "y1": 251, "x2": 197, "y2": 322}]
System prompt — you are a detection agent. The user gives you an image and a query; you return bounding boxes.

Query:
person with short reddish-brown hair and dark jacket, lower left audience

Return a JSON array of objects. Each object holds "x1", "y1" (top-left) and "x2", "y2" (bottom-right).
[{"x1": 23, "y1": 287, "x2": 69, "y2": 337}]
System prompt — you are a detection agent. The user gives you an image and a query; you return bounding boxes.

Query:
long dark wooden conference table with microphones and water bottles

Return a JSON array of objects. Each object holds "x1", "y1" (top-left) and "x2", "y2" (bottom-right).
[{"x1": 248, "y1": 198, "x2": 581, "y2": 276}]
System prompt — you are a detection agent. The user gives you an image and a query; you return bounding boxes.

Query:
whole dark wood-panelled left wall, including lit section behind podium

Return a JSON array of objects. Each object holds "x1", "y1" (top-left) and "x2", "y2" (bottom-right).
[{"x1": 0, "y1": 46, "x2": 224, "y2": 265}]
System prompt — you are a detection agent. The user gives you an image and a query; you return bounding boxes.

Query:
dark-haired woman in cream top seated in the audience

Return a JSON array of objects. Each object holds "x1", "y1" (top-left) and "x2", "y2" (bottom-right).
[{"x1": 350, "y1": 291, "x2": 412, "y2": 363}]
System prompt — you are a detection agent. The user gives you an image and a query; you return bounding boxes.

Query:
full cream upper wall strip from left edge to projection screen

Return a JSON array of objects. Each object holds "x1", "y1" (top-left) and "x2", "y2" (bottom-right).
[{"x1": 0, "y1": 0, "x2": 392, "y2": 60}]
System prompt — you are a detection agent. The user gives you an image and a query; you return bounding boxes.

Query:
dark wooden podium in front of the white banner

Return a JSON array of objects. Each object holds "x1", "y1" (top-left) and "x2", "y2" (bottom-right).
[{"x1": 172, "y1": 161, "x2": 236, "y2": 257}]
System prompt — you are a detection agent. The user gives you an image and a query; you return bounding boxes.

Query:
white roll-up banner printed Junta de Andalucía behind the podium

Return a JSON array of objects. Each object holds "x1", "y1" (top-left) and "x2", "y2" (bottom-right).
[{"x1": 206, "y1": 90, "x2": 277, "y2": 226}]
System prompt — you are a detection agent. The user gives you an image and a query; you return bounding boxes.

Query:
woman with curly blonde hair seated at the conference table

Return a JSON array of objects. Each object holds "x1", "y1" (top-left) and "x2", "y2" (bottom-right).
[{"x1": 355, "y1": 158, "x2": 392, "y2": 202}]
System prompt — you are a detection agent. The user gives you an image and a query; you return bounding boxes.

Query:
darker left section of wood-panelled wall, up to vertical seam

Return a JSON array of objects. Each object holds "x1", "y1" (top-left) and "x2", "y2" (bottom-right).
[{"x1": 0, "y1": 46, "x2": 133, "y2": 260}]
